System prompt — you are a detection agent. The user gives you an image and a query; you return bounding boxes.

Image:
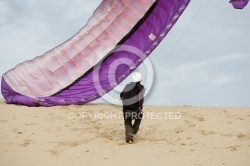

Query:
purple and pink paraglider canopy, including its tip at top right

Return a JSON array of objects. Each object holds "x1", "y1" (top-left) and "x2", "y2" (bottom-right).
[{"x1": 1, "y1": 0, "x2": 249, "y2": 107}]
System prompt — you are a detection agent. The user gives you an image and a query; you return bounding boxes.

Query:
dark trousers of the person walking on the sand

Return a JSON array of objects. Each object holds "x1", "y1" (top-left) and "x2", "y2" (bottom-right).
[{"x1": 124, "y1": 112, "x2": 142, "y2": 140}]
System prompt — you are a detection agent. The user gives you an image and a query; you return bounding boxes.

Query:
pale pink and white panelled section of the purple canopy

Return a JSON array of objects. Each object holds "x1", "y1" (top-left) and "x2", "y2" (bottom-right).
[{"x1": 3, "y1": 0, "x2": 157, "y2": 98}]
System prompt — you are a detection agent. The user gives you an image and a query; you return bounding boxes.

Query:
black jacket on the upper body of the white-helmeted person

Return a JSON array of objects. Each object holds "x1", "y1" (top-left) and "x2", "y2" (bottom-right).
[{"x1": 120, "y1": 82, "x2": 144, "y2": 111}]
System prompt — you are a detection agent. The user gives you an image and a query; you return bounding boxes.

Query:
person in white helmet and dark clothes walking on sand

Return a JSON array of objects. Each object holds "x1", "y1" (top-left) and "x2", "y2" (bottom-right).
[{"x1": 120, "y1": 72, "x2": 145, "y2": 144}]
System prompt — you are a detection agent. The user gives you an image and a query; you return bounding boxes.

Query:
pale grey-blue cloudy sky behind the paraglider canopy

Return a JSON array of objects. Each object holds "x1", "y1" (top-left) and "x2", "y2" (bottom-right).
[{"x1": 0, "y1": 0, "x2": 250, "y2": 107}]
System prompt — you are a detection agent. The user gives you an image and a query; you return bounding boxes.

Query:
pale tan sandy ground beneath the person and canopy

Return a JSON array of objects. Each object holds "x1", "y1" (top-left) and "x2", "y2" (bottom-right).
[{"x1": 0, "y1": 100, "x2": 250, "y2": 166}]
